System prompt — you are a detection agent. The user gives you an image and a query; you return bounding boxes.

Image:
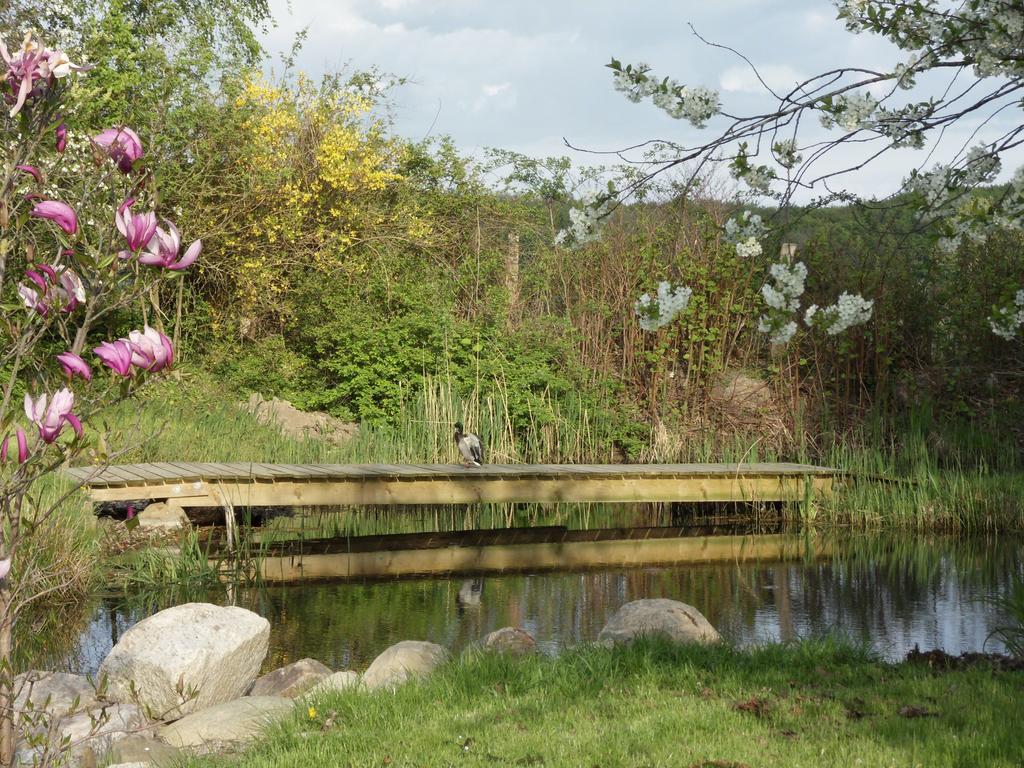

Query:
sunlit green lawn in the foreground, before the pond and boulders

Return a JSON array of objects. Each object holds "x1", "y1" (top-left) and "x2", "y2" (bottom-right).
[{"x1": 189, "y1": 641, "x2": 1024, "y2": 768}]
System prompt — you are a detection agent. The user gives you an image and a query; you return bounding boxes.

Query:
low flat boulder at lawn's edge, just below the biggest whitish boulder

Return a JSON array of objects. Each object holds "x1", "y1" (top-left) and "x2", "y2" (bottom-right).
[{"x1": 160, "y1": 696, "x2": 294, "y2": 753}]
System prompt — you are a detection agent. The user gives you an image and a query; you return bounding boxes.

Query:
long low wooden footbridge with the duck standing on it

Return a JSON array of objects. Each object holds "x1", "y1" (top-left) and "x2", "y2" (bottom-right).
[{"x1": 67, "y1": 462, "x2": 839, "y2": 508}]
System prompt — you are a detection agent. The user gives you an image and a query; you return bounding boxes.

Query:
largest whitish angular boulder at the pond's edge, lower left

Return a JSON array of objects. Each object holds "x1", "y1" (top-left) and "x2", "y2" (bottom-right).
[{"x1": 99, "y1": 603, "x2": 270, "y2": 720}]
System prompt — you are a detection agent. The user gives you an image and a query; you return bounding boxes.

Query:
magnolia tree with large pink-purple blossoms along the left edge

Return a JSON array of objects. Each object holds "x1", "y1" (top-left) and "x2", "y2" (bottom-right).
[{"x1": 0, "y1": 35, "x2": 202, "y2": 766}]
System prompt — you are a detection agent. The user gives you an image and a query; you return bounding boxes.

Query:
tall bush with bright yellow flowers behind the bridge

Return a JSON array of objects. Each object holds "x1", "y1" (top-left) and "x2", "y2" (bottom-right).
[{"x1": 188, "y1": 75, "x2": 431, "y2": 330}]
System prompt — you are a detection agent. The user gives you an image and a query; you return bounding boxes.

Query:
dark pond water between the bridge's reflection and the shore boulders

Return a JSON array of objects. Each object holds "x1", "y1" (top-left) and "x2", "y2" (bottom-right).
[{"x1": 55, "y1": 507, "x2": 1024, "y2": 674}]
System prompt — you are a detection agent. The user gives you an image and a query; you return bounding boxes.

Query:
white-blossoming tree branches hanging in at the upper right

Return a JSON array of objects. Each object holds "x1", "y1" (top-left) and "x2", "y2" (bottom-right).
[{"x1": 566, "y1": 0, "x2": 1024, "y2": 342}]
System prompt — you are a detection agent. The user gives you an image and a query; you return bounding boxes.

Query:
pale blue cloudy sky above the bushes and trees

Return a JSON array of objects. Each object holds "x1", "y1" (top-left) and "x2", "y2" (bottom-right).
[{"x1": 264, "y1": 0, "x2": 1024, "y2": 196}]
